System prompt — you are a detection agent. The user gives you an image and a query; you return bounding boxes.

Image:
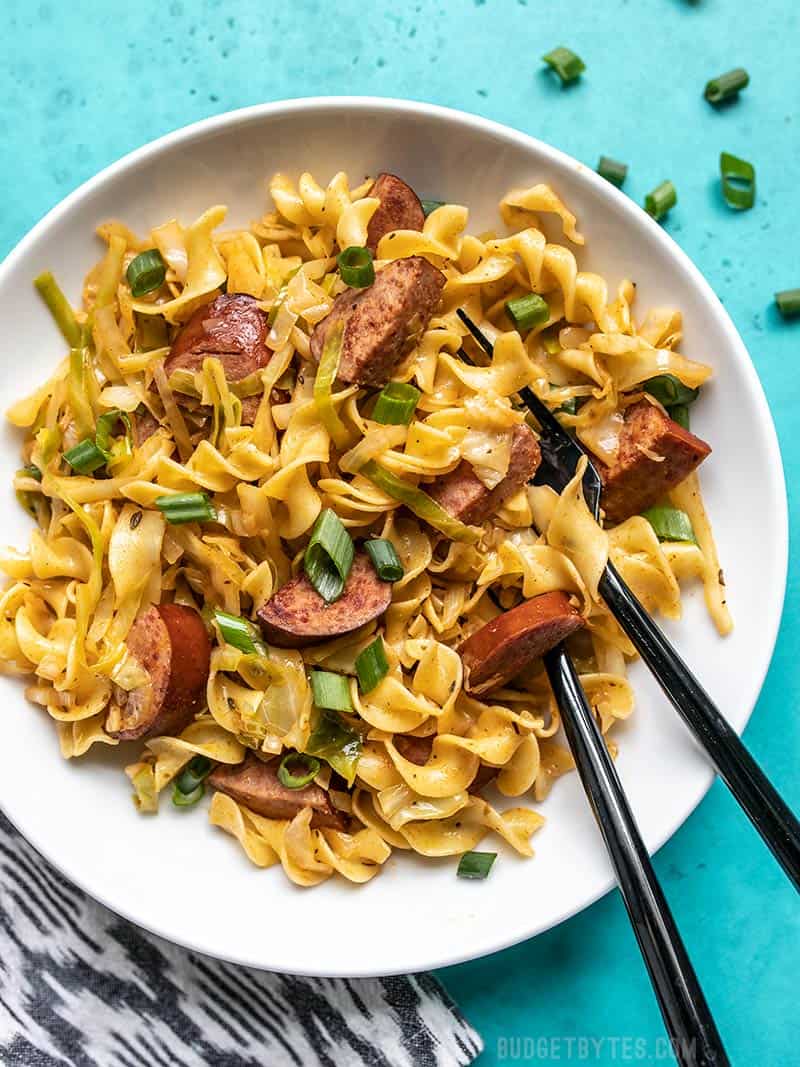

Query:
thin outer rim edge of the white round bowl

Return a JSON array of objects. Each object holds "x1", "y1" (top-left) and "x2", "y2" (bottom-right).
[{"x1": 0, "y1": 95, "x2": 789, "y2": 977}]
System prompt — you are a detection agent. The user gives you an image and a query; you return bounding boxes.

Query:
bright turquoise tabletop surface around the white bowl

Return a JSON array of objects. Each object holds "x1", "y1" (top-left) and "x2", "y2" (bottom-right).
[{"x1": 0, "y1": 0, "x2": 800, "y2": 1065}]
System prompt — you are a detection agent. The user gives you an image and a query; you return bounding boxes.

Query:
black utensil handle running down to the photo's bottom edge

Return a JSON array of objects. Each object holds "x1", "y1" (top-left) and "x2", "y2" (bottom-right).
[{"x1": 544, "y1": 644, "x2": 730, "y2": 1067}]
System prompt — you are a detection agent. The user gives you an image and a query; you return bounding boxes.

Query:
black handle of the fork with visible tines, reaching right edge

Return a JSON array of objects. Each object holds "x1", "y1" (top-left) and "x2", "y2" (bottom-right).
[{"x1": 599, "y1": 561, "x2": 800, "y2": 890}]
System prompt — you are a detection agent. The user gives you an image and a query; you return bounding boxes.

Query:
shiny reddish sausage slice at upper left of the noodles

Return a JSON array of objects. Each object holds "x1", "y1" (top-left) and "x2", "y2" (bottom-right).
[{"x1": 164, "y1": 292, "x2": 272, "y2": 382}]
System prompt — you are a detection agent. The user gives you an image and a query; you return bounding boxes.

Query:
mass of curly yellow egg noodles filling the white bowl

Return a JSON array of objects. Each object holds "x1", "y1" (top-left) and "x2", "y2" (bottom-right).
[{"x1": 0, "y1": 173, "x2": 731, "y2": 886}]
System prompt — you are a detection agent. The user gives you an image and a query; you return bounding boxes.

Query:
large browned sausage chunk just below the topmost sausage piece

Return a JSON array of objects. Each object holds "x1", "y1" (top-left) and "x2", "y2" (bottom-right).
[{"x1": 310, "y1": 256, "x2": 445, "y2": 385}]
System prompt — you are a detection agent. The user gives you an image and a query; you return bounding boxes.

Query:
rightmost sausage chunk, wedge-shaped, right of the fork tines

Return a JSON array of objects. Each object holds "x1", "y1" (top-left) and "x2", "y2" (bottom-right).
[{"x1": 594, "y1": 400, "x2": 711, "y2": 526}]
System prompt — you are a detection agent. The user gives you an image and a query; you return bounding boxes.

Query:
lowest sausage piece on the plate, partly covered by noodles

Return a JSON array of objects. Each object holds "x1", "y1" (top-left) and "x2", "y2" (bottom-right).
[{"x1": 208, "y1": 754, "x2": 348, "y2": 830}]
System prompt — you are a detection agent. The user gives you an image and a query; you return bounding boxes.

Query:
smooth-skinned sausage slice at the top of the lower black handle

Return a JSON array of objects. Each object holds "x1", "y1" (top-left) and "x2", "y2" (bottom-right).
[{"x1": 459, "y1": 592, "x2": 583, "y2": 695}]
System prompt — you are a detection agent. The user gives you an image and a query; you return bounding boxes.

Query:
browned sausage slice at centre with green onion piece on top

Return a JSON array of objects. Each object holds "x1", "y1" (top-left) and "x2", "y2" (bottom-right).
[{"x1": 258, "y1": 553, "x2": 391, "y2": 649}]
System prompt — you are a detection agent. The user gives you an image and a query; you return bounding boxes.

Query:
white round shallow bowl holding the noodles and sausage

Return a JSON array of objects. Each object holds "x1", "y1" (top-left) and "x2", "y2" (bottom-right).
[{"x1": 0, "y1": 98, "x2": 787, "y2": 975}]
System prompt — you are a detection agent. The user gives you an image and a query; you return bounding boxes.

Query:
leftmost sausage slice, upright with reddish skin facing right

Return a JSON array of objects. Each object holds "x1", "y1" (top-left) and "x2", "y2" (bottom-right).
[{"x1": 109, "y1": 604, "x2": 211, "y2": 740}]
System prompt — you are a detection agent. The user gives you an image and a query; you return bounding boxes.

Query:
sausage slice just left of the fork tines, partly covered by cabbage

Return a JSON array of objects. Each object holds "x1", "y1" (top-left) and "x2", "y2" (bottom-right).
[{"x1": 426, "y1": 423, "x2": 542, "y2": 525}]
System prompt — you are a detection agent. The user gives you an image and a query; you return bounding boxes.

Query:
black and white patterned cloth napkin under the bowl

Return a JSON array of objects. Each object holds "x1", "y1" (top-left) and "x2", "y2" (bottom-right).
[{"x1": 0, "y1": 814, "x2": 482, "y2": 1067}]
